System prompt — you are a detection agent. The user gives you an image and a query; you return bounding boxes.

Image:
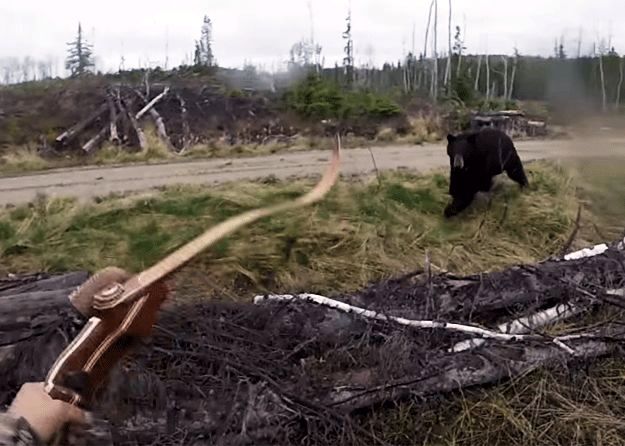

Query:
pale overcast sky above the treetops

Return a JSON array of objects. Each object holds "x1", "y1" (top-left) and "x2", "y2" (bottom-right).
[{"x1": 0, "y1": 0, "x2": 625, "y2": 71}]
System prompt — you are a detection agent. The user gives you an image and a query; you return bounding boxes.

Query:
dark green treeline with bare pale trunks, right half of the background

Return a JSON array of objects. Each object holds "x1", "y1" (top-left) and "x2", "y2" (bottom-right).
[{"x1": 300, "y1": 51, "x2": 625, "y2": 111}]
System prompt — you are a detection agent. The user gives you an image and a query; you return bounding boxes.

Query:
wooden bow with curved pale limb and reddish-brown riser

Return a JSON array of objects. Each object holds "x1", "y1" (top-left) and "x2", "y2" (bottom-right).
[{"x1": 45, "y1": 135, "x2": 341, "y2": 408}]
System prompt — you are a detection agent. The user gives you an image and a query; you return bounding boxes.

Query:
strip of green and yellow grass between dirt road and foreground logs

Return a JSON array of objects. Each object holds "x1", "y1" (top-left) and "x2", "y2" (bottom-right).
[{"x1": 0, "y1": 164, "x2": 577, "y2": 292}]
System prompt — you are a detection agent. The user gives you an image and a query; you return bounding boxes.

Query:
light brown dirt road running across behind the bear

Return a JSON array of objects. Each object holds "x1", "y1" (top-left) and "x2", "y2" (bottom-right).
[{"x1": 0, "y1": 137, "x2": 625, "y2": 206}]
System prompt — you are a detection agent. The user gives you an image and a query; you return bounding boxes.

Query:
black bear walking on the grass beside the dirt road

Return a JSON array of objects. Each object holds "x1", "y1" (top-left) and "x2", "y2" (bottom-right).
[{"x1": 445, "y1": 128, "x2": 529, "y2": 218}]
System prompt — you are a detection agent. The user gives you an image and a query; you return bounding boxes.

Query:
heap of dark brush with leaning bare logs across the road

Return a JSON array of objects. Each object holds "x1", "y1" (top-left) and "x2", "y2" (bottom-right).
[{"x1": 52, "y1": 83, "x2": 296, "y2": 154}]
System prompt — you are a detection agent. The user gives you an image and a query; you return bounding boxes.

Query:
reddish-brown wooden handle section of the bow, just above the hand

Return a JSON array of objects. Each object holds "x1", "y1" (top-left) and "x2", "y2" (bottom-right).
[{"x1": 45, "y1": 281, "x2": 168, "y2": 410}]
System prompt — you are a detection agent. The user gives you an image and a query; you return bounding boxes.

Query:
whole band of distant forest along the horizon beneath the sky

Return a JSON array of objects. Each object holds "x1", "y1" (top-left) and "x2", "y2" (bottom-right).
[{"x1": 0, "y1": 9, "x2": 625, "y2": 112}]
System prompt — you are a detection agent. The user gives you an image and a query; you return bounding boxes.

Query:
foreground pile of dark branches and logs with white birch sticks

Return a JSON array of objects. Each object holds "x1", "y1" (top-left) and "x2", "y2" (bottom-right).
[{"x1": 0, "y1": 242, "x2": 625, "y2": 445}]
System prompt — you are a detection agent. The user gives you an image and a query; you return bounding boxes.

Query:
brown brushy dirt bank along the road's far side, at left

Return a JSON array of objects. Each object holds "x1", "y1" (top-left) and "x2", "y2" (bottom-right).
[{"x1": 0, "y1": 76, "x2": 408, "y2": 154}]
